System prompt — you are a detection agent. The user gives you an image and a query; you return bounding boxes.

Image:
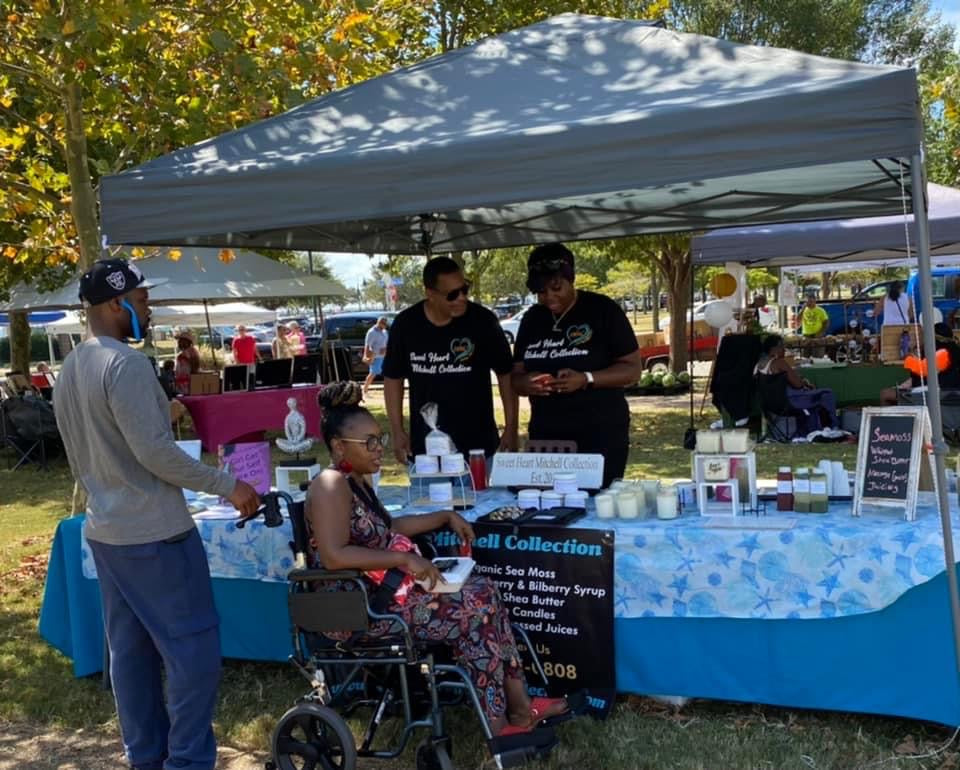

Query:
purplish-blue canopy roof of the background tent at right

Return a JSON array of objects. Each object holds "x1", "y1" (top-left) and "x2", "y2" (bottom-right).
[{"x1": 692, "y1": 184, "x2": 960, "y2": 270}]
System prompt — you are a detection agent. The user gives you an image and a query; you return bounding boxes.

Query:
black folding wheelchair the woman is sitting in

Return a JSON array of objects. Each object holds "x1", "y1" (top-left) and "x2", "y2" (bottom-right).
[{"x1": 265, "y1": 493, "x2": 562, "y2": 770}]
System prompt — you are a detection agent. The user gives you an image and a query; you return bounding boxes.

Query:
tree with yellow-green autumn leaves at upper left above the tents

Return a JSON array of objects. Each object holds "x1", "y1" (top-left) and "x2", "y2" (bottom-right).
[{"x1": 0, "y1": 0, "x2": 426, "y2": 366}]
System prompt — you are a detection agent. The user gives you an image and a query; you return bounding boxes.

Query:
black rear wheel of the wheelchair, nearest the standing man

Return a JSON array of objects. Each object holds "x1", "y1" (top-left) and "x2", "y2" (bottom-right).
[{"x1": 271, "y1": 703, "x2": 357, "y2": 770}]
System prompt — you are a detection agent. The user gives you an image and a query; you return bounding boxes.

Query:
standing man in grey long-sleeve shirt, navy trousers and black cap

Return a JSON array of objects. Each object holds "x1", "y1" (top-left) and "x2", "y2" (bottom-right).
[{"x1": 54, "y1": 259, "x2": 260, "y2": 770}]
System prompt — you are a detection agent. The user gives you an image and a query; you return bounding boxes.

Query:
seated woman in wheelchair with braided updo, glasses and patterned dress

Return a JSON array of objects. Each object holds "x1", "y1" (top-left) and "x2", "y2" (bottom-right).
[{"x1": 306, "y1": 382, "x2": 568, "y2": 735}]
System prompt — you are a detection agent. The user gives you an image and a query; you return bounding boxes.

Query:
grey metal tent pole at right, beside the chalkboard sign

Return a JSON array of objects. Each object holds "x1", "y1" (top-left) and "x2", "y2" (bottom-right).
[{"x1": 910, "y1": 153, "x2": 960, "y2": 680}]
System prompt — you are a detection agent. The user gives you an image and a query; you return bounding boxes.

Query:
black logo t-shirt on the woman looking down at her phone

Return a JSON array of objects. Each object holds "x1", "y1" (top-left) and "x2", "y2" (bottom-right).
[{"x1": 513, "y1": 291, "x2": 637, "y2": 426}]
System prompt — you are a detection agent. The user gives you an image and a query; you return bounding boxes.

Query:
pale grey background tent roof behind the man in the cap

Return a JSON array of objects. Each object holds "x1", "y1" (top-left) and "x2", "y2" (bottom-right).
[{"x1": 0, "y1": 248, "x2": 347, "y2": 310}]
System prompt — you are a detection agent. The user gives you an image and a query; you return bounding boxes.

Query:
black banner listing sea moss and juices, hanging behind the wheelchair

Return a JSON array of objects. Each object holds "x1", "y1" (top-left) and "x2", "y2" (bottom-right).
[{"x1": 434, "y1": 524, "x2": 616, "y2": 717}]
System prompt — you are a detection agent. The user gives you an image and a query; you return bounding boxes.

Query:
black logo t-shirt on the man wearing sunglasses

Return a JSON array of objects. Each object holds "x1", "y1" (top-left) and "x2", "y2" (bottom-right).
[{"x1": 383, "y1": 301, "x2": 513, "y2": 455}]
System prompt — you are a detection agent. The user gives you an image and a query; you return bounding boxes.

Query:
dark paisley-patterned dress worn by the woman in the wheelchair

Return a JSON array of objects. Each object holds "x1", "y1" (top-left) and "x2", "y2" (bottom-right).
[{"x1": 314, "y1": 480, "x2": 523, "y2": 720}]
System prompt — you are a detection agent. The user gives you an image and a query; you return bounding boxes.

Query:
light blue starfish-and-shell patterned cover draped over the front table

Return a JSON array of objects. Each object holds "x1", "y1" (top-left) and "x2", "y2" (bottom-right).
[{"x1": 77, "y1": 487, "x2": 960, "y2": 619}]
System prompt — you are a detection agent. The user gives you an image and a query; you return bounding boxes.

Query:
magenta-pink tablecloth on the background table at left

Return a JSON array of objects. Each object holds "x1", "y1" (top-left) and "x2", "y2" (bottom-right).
[{"x1": 180, "y1": 385, "x2": 322, "y2": 452}]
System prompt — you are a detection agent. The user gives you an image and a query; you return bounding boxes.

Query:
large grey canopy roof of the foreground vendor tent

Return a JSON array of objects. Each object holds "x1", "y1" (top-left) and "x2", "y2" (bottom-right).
[{"x1": 101, "y1": 14, "x2": 921, "y2": 253}]
